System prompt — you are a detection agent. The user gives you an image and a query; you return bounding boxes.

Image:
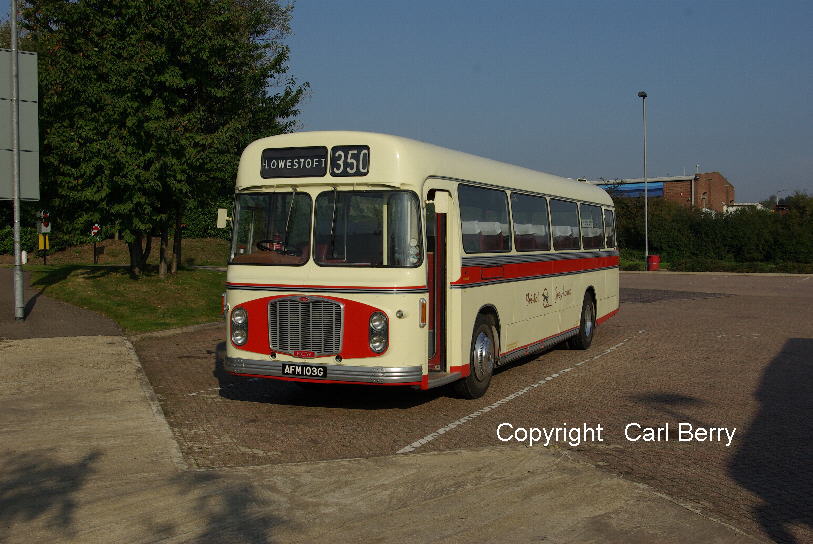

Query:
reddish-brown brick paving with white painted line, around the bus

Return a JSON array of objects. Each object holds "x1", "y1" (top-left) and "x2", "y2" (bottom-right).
[{"x1": 135, "y1": 274, "x2": 813, "y2": 542}]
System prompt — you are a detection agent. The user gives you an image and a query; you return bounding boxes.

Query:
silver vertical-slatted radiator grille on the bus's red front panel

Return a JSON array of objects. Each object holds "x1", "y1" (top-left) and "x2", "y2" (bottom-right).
[{"x1": 268, "y1": 297, "x2": 342, "y2": 356}]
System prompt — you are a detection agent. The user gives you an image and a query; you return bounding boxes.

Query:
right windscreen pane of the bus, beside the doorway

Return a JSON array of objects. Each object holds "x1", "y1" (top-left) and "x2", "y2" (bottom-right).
[{"x1": 314, "y1": 190, "x2": 422, "y2": 267}]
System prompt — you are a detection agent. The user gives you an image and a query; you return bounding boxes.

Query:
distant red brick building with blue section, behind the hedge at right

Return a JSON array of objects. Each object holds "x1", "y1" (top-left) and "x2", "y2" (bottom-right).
[{"x1": 588, "y1": 172, "x2": 734, "y2": 212}]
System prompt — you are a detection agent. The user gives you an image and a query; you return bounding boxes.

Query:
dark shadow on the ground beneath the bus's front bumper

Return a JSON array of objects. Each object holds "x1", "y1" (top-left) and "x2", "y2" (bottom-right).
[{"x1": 212, "y1": 342, "x2": 450, "y2": 410}]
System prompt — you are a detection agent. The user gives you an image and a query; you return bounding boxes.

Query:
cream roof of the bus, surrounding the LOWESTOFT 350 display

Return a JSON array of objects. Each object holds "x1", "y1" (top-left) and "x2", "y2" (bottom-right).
[{"x1": 237, "y1": 131, "x2": 612, "y2": 206}]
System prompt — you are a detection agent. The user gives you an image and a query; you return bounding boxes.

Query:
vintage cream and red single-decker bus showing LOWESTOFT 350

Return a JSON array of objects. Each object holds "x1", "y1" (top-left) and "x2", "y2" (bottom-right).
[{"x1": 218, "y1": 131, "x2": 619, "y2": 398}]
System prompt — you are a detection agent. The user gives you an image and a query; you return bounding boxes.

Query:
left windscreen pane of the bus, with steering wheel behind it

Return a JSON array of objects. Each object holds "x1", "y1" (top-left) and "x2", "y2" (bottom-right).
[{"x1": 231, "y1": 191, "x2": 311, "y2": 265}]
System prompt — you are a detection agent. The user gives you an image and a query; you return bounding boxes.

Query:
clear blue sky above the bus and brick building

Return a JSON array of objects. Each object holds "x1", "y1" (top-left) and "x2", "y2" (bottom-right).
[{"x1": 6, "y1": 0, "x2": 813, "y2": 202}]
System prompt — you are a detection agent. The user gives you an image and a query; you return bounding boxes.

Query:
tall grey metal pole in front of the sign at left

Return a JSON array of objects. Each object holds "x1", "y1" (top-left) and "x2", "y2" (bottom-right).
[{"x1": 11, "y1": 0, "x2": 25, "y2": 320}]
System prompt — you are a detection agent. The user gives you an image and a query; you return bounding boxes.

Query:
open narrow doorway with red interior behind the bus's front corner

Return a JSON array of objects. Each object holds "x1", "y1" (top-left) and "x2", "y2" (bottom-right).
[{"x1": 426, "y1": 189, "x2": 450, "y2": 372}]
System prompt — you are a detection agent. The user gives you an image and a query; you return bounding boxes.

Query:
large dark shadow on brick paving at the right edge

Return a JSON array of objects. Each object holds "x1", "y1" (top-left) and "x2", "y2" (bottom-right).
[{"x1": 728, "y1": 338, "x2": 813, "y2": 543}]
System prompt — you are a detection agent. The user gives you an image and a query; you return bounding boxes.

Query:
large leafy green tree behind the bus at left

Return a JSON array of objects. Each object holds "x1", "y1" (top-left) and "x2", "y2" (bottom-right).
[{"x1": 22, "y1": 0, "x2": 307, "y2": 276}]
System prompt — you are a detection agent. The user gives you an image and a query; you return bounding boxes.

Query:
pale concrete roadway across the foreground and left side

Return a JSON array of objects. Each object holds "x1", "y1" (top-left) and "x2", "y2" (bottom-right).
[{"x1": 0, "y1": 268, "x2": 751, "y2": 543}]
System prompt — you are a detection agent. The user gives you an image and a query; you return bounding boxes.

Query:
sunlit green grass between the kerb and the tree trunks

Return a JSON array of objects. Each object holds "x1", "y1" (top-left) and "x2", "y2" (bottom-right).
[{"x1": 26, "y1": 265, "x2": 226, "y2": 333}]
